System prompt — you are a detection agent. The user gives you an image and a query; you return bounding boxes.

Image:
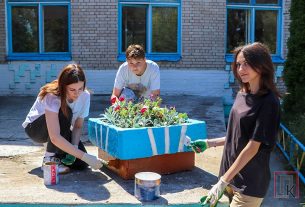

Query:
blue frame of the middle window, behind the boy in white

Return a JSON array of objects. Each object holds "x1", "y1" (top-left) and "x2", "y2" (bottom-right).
[{"x1": 117, "y1": 0, "x2": 182, "y2": 62}]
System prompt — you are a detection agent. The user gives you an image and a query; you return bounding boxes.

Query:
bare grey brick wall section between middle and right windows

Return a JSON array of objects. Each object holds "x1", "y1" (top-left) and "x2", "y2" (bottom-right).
[{"x1": 160, "y1": 0, "x2": 226, "y2": 70}]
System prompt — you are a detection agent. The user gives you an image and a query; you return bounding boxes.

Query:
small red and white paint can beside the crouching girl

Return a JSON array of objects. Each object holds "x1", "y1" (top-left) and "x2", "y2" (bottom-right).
[{"x1": 43, "y1": 162, "x2": 59, "y2": 185}]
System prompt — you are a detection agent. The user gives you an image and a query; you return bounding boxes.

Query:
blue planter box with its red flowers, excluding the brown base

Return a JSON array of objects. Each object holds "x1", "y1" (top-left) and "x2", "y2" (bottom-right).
[{"x1": 88, "y1": 100, "x2": 207, "y2": 160}]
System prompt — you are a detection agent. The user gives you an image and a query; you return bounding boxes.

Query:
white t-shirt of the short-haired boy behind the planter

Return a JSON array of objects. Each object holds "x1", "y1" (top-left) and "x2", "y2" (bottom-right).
[{"x1": 114, "y1": 60, "x2": 160, "y2": 98}]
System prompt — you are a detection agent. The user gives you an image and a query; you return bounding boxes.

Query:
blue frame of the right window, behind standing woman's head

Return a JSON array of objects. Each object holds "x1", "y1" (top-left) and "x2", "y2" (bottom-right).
[{"x1": 225, "y1": 0, "x2": 285, "y2": 63}]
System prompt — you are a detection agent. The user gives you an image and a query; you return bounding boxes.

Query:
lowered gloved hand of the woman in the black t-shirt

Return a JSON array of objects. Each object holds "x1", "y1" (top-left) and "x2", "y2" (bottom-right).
[{"x1": 203, "y1": 177, "x2": 229, "y2": 207}]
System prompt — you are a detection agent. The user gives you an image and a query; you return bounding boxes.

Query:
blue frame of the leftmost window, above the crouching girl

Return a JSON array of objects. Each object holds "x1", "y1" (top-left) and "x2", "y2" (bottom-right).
[{"x1": 7, "y1": 0, "x2": 72, "y2": 60}]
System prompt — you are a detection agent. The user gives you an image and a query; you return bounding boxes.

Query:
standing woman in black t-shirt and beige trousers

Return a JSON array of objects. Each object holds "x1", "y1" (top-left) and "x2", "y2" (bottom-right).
[{"x1": 192, "y1": 43, "x2": 280, "y2": 207}]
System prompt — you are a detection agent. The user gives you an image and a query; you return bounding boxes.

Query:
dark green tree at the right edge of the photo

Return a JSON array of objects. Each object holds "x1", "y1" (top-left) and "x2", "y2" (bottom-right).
[{"x1": 283, "y1": 0, "x2": 305, "y2": 142}]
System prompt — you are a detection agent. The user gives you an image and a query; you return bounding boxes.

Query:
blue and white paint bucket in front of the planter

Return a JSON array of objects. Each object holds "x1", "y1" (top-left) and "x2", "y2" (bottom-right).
[{"x1": 134, "y1": 172, "x2": 161, "y2": 201}]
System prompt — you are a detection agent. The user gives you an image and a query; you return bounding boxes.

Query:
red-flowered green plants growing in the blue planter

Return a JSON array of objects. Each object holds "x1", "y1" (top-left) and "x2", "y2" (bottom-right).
[{"x1": 102, "y1": 98, "x2": 188, "y2": 128}]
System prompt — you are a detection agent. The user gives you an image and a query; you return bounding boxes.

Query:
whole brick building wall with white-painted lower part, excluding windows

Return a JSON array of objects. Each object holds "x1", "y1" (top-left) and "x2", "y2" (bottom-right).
[{"x1": 0, "y1": 0, "x2": 291, "y2": 95}]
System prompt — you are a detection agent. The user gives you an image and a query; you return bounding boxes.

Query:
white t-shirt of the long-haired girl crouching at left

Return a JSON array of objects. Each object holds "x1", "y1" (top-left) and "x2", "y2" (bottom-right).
[{"x1": 22, "y1": 90, "x2": 90, "y2": 128}]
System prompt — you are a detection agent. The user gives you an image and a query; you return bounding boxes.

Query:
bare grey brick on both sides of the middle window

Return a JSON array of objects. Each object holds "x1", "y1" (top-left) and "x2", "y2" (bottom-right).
[{"x1": 72, "y1": 0, "x2": 226, "y2": 70}]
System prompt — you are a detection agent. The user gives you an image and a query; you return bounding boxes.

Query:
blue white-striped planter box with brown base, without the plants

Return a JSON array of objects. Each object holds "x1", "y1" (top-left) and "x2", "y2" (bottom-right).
[{"x1": 88, "y1": 118, "x2": 207, "y2": 179}]
